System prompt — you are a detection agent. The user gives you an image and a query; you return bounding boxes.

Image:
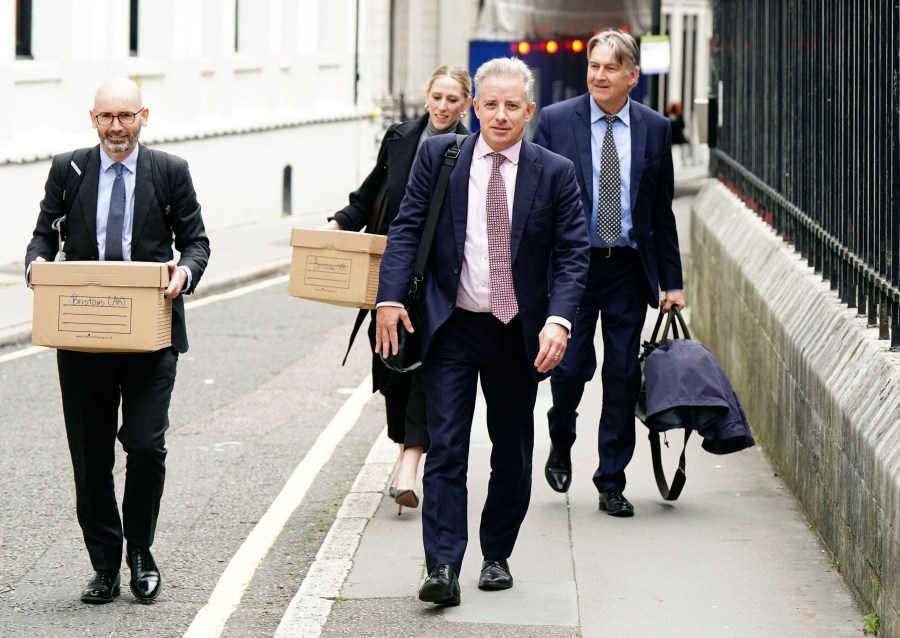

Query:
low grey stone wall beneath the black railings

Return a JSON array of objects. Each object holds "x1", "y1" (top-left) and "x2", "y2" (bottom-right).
[{"x1": 691, "y1": 183, "x2": 900, "y2": 638}]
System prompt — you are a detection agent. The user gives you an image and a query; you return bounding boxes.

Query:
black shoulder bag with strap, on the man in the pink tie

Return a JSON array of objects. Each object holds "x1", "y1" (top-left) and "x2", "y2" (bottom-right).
[{"x1": 379, "y1": 133, "x2": 467, "y2": 372}]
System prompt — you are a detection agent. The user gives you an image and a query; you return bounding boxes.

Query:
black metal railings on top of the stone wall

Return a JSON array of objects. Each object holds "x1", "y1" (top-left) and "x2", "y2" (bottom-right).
[{"x1": 710, "y1": 0, "x2": 900, "y2": 350}]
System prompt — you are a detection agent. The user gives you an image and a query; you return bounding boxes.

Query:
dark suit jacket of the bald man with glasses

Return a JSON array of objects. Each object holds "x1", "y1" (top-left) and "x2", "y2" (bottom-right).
[{"x1": 25, "y1": 145, "x2": 209, "y2": 352}]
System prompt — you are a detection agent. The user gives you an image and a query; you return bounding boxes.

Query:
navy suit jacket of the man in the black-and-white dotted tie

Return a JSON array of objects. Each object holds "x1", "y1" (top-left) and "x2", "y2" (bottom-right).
[{"x1": 533, "y1": 93, "x2": 684, "y2": 308}]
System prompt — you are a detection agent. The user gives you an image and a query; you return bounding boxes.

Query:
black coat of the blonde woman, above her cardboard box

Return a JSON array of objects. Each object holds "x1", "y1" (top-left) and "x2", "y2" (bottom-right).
[{"x1": 329, "y1": 113, "x2": 469, "y2": 235}]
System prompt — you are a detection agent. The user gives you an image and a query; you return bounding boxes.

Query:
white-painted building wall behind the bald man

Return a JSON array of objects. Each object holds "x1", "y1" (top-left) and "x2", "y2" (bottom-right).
[{"x1": 0, "y1": 0, "x2": 389, "y2": 265}]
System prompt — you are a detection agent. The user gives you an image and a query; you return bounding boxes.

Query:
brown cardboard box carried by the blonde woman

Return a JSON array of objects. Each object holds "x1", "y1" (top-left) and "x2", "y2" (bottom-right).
[{"x1": 288, "y1": 228, "x2": 387, "y2": 308}]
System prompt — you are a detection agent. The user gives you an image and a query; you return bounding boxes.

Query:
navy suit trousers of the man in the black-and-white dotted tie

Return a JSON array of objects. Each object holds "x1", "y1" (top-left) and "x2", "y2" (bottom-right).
[{"x1": 547, "y1": 249, "x2": 647, "y2": 491}]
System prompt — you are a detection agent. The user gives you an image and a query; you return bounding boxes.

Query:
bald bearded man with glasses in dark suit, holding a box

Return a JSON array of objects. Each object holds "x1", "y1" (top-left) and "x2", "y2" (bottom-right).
[{"x1": 25, "y1": 79, "x2": 209, "y2": 604}]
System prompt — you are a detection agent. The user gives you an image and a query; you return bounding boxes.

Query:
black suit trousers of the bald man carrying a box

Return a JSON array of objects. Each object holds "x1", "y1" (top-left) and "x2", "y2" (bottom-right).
[{"x1": 57, "y1": 347, "x2": 178, "y2": 570}]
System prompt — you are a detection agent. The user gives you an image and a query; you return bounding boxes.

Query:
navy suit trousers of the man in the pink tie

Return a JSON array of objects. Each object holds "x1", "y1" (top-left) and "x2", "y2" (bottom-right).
[{"x1": 422, "y1": 308, "x2": 537, "y2": 574}]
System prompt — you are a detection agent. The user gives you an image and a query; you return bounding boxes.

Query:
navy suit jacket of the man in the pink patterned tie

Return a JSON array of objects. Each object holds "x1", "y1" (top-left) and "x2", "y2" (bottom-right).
[{"x1": 378, "y1": 135, "x2": 590, "y2": 379}]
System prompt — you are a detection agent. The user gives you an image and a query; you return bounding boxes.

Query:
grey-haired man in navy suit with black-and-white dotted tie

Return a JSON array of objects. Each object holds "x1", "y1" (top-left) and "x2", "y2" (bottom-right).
[{"x1": 534, "y1": 29, "x2": 684, "y2": 516}]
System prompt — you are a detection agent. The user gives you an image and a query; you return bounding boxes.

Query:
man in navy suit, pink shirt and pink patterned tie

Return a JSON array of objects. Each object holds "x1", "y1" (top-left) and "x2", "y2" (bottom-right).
[{"x1": 375, "y1": 58, "x2": 589, "y2": 605}]
